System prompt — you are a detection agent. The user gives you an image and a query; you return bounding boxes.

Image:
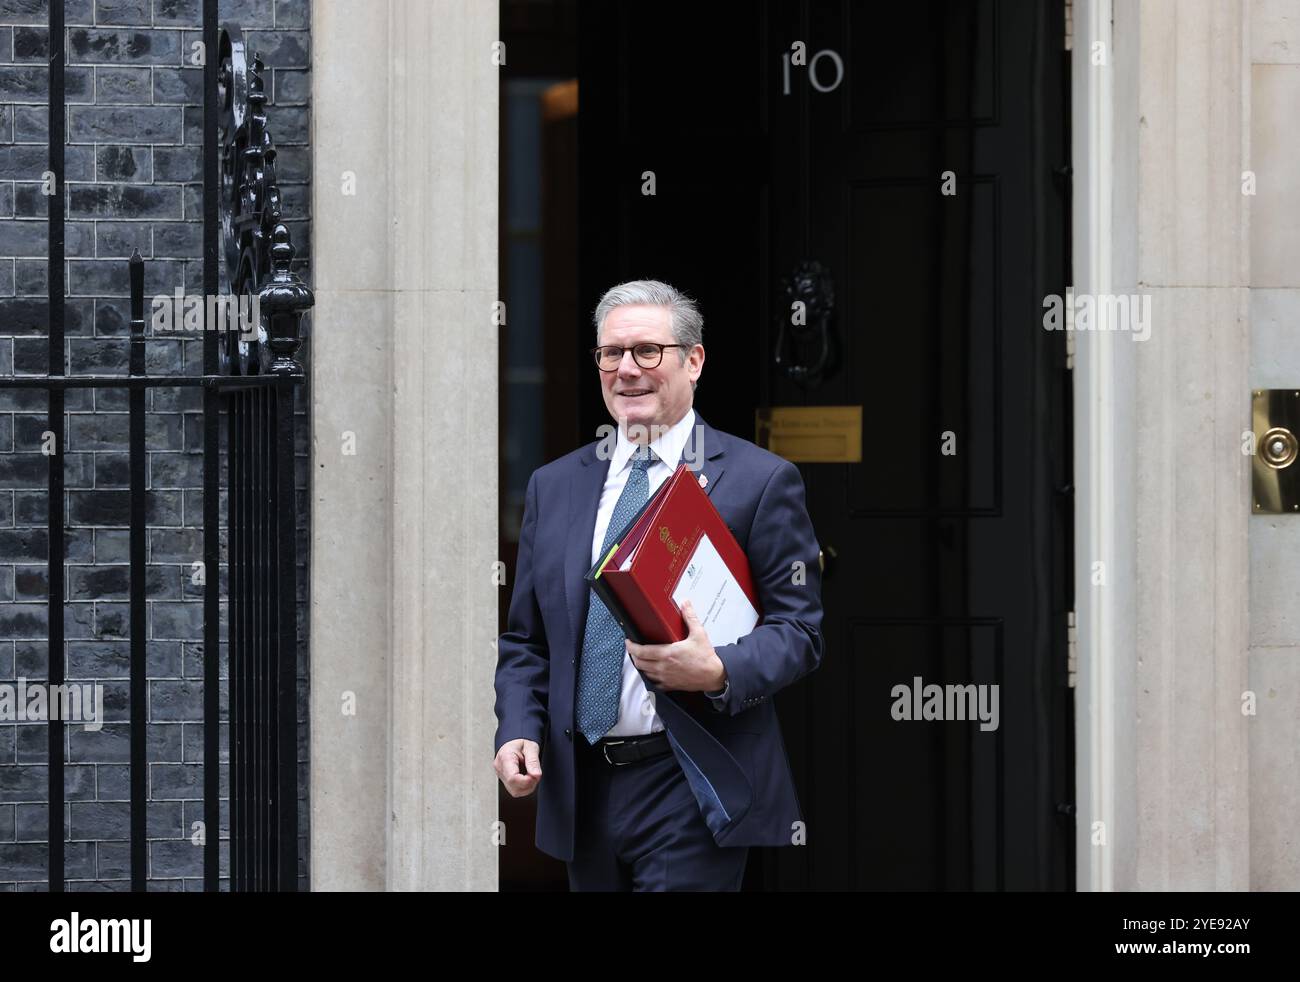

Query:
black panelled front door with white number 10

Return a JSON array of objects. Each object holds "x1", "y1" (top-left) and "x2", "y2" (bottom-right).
[{"x1": 576, "y1": 0, "x2": 1074, "y2": 890}]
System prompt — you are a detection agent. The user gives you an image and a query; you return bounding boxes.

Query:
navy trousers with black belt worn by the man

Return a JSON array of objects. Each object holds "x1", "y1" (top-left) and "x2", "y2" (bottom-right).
[{"x1": 567, "y1": 734, "x2": 749, "y2": 891}]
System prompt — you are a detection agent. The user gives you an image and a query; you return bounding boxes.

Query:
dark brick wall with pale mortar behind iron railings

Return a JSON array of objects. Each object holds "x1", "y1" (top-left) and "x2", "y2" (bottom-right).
[{"x1": 0, "y1": 0, "x2": 311, "y2": 891}]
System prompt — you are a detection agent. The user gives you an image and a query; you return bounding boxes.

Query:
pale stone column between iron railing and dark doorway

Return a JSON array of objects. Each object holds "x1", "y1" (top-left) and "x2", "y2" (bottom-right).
[{"x1": 311, "y1": 0, "x2": 499, "y2": 890}]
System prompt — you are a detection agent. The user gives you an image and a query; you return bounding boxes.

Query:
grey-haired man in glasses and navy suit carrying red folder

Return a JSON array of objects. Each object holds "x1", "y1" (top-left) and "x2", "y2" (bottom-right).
[{"x1": 494, "y1": 280, "x2": 824, "y2": 890}]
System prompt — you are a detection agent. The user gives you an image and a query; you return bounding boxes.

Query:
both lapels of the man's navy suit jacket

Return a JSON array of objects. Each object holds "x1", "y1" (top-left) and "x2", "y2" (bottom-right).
[{"x1": 564, "y1": 410, "x2": 725, "y2": 652}]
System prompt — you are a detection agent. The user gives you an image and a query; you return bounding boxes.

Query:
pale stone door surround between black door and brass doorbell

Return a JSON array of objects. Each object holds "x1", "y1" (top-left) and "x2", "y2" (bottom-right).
[{"x1": 1074, "y1": 0, "x2": 1251, "y2": 890}]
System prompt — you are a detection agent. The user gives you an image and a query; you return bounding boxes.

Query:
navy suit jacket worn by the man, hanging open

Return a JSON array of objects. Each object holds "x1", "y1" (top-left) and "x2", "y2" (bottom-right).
[{"x1": 494, "y1": 411, "x2": 824, "y2": 862}]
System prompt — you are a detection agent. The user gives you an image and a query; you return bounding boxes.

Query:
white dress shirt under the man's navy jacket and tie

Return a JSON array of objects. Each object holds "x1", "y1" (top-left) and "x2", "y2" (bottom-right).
[{"x1": 592, "y1": 408, "x2": 727, "y2": 736}]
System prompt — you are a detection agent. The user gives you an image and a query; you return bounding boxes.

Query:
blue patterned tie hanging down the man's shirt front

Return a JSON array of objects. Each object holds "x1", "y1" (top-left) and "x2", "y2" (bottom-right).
[{"x1": 577, "y1": 447, "x2": 654, "y2": 744}]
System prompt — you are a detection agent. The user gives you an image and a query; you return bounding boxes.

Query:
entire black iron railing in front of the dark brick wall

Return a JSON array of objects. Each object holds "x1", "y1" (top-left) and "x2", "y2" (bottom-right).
[{"x1": 0, "y1": 0, "x2": 313, "y2": 892}]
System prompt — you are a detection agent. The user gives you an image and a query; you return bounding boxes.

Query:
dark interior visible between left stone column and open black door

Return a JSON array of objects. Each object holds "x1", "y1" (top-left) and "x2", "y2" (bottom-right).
[{"x1": 497, "y1": 0, "x2": 584, "y2": 891}]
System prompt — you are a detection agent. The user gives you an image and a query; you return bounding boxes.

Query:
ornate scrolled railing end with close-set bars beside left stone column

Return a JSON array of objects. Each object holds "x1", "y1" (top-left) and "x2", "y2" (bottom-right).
[{"x1": 218, "y1": 17, "x2": 313, "y2": 890}]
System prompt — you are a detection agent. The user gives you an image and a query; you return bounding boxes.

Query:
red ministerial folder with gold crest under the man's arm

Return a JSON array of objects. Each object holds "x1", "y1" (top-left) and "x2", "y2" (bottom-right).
[{"x1": 586, "y1": 463, "x2": 762, "y2": 644}]
